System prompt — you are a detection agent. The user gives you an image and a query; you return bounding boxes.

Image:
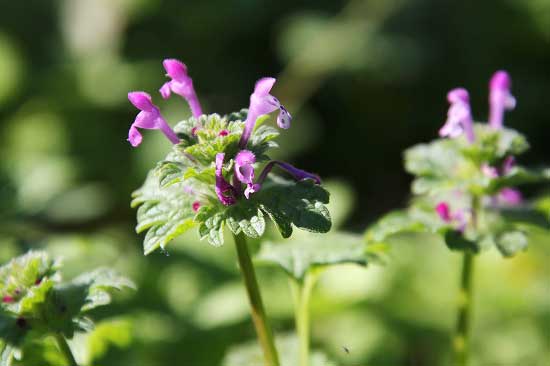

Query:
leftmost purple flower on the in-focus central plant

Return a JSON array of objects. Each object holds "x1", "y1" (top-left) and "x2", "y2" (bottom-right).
[{"x1": 128, "y1": 91, "x2": 180, "y2": 147}]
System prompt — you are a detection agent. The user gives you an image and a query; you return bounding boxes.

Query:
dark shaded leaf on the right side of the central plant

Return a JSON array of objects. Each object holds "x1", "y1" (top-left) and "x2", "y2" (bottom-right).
[{"x1": 251, "y1": 176, "x2": 331, "y2": 237}]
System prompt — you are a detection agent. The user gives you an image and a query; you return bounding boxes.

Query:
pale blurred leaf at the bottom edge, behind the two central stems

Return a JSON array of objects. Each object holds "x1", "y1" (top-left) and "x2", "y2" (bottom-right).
[{"x1": 222, "y1": 334, "x2": 336, "y2": 366}]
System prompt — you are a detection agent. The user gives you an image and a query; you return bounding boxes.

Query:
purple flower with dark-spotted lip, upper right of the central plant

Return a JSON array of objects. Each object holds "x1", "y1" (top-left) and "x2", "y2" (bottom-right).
[{"x1": 239, "y1": 78, "x2": 292, "y2": 148}]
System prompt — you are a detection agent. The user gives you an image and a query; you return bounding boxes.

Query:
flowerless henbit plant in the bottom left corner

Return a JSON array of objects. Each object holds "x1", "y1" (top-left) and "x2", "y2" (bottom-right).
[{"x1": 0, "y1": 251, "x2": 135, "y2": 366}]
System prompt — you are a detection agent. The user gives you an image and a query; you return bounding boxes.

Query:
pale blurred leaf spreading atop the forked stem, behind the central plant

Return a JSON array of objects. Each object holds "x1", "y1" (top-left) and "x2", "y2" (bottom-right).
[{"x1": 255, "y1": 232, "x2": 367, "y2": 281}]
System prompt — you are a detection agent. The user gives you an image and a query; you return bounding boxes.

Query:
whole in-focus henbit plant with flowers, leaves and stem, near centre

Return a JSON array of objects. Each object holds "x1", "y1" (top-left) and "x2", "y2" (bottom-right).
[{"x1": 128, "y1": 59, "x2": 331, "y2": 365}]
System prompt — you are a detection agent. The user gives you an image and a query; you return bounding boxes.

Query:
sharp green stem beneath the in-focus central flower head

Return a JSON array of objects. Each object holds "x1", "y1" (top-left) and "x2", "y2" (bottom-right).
[{"x1": 233, "y1": 233, "x2": 279, "y2": 366}]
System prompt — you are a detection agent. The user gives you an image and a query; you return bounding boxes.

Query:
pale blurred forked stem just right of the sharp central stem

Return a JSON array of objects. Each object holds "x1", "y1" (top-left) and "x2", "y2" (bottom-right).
[{"x1": 290, "y1": 273, "x2": 317, "y2": 366}]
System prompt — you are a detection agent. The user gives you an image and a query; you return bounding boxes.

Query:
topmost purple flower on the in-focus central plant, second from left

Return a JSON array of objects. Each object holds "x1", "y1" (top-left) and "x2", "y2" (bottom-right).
[{"x1": 160, "y1": 59, "x2": 202, "y2": 117}]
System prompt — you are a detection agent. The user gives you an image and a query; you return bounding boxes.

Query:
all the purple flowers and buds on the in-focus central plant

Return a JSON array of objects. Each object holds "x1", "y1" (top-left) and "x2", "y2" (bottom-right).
[{"x1": 128, "y1": 59, "x2": 320, "y2": 207}]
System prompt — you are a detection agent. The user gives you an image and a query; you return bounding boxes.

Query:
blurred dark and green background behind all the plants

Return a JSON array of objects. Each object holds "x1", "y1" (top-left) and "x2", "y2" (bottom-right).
[{"x1": 0, "y1": 0, "x2": 550, "y2": 366}]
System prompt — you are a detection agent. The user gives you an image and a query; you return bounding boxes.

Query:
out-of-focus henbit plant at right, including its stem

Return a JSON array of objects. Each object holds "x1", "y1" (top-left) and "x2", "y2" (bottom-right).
[{"x1": 366, "y1": 71, "x2": 550, "y2": 365}]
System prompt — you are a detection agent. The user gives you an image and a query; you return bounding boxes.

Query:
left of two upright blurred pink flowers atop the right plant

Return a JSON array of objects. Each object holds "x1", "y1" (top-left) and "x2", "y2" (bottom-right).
[{"x1": 439, "y1": 88, "x2": 475, "y2": 142}]
